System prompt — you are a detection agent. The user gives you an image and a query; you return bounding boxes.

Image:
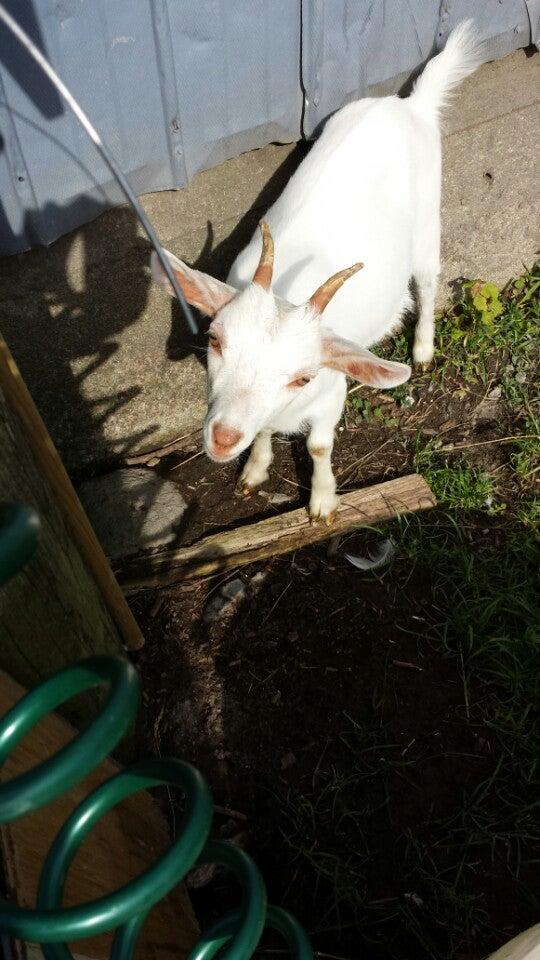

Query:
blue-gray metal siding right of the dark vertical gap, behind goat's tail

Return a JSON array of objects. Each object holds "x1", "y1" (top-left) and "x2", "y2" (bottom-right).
[{"x1": 302, "y1": 0, "x2": 540, "y2": 137}]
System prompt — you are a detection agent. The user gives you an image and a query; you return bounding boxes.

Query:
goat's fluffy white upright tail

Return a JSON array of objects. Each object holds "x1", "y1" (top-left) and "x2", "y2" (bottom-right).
[{"x1": 411, "y1": 20, "x2": 485, "y2": 122}]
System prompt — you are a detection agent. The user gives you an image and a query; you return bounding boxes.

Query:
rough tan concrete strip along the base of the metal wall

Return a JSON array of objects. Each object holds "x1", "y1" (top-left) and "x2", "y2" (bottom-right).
[{"x1": 0, "y1": 51, "x2": 540, "y2": 472}]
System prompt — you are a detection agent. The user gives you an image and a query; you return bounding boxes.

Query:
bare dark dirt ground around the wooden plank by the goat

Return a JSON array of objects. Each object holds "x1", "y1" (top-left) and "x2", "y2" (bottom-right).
[{"x1": 127, "y1": 324, "x2": 535, "y2": 960}]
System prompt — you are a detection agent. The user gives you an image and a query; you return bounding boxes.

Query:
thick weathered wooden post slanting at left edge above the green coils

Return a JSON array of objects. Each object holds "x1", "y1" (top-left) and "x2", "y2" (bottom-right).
[{"x1": 0, "y1": 339, "x2": 142, "y2": 704}]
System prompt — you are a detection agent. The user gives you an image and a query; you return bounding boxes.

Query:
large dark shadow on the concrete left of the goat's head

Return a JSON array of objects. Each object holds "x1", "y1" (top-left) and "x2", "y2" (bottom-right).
[{"x1": 2, "y1": 201, "x2": 156, "y2": 476}]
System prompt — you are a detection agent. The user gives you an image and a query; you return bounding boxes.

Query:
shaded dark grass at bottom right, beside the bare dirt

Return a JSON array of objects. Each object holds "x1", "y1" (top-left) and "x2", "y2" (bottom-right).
[{"x1": 281, "y1": 512, "x2": 540, "y2": 960}]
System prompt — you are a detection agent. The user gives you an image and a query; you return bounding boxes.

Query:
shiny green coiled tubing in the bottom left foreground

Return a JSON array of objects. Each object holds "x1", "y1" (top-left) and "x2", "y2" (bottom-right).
[{"x1": 0, "y1": 505, "x2": 313, "y2": 960}]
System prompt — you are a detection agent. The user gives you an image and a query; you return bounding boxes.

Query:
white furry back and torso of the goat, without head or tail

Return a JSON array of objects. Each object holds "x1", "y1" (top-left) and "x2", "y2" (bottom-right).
[{"x1": 229, "y1": 97, "x2": 440, "y2": 343}]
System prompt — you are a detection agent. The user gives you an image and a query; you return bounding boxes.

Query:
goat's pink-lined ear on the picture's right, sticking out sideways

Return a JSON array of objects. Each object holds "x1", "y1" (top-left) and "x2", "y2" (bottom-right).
[{"x1": 322, "y1": 330, "x2": 411, "y2": 390}]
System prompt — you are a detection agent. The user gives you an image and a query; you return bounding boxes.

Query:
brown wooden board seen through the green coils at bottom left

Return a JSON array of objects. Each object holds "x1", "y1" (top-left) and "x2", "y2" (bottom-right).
[{"x1": 0, "y1": 673, "x2": 198, "y2": 960}]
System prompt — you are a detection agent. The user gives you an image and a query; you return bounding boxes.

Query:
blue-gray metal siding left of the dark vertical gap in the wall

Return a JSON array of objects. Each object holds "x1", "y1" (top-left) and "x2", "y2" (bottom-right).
[{"x1": 0, "y1": 0, "x2": 302, "y2": 254}]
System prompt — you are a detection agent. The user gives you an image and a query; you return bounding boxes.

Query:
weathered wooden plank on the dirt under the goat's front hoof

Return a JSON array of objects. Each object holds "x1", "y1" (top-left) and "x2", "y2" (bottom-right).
[{"x1": 119, "y1": 474, "x2": 436, "y2": 594}]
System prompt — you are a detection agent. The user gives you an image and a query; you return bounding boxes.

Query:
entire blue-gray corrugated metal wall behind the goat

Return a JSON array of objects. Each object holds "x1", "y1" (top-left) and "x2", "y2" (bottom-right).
[{"x1": 0, "y1": 0, "x2": 540, "y2": 254}]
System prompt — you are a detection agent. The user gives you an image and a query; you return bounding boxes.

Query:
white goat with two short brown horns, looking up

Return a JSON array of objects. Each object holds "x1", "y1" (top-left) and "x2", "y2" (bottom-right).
[{"x1": 152, "y1": 21, "x2": 482, "y2": 523}]
